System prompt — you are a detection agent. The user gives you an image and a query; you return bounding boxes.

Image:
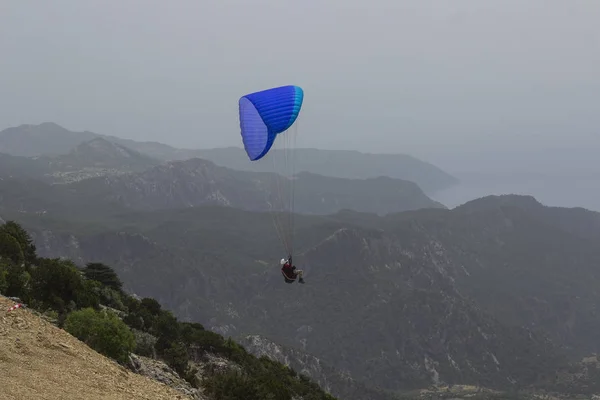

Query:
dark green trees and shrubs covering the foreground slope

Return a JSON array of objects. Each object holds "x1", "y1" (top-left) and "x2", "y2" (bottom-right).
[{"x1": 0, "y1": 221, "x2": 334, "y2": 400}]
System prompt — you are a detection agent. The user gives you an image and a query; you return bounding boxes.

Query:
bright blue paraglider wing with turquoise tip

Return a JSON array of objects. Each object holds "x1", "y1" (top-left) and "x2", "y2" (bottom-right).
[{"x1": 239, "y1": 85, "x2": 304, "y2": 161}]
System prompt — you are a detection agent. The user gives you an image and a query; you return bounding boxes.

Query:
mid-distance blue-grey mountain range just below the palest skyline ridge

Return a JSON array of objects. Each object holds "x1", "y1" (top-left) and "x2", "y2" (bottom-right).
[{"x1": 0, "y1": 138, "x2": 444, "y2": 218}]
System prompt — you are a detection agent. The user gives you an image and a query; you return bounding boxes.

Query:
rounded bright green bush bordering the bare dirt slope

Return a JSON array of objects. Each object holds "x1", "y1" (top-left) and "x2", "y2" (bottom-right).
[{"x1": 65, "y1": 308, "x2": 135, "y2": 363}]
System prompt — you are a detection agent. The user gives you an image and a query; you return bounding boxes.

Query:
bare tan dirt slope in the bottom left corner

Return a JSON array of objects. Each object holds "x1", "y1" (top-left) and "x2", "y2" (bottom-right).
[{"x1": 0, "y1": 296, "x2": 189, "y2": 400}]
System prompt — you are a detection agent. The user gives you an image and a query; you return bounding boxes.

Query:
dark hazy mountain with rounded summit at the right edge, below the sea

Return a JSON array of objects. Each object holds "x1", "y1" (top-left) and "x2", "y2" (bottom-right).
[{"x1": 430, "y1": 198, "x2": 600, "y2": 357}]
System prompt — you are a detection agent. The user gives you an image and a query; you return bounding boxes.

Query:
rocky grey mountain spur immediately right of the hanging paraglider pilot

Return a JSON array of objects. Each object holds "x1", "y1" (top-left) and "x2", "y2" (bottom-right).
[{"x1": 255, "y1": 229, "x2": 560, "y2": 390}]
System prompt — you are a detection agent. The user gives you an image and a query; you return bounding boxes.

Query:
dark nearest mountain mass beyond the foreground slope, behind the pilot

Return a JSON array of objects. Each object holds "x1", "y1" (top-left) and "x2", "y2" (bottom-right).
[{"x1": 7, "y1": 196, "x2": 599, "y2": 396}]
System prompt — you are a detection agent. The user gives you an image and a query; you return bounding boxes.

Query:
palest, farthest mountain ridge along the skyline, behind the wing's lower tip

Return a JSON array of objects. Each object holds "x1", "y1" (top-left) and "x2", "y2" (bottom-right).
[{"x1": 0, "y1": 122, "x2": 458, "y2": 193}]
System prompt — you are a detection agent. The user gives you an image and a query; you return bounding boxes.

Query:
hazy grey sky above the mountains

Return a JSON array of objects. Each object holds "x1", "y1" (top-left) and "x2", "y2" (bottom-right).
[{"x1": 0, "y1": 0, "x2": 600, "y2": 170}]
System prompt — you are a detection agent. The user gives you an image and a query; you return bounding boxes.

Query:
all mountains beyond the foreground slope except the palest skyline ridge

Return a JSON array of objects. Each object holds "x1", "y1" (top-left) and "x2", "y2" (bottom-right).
[{"x1": 0, "y1": 121, "x2": 600, "y2": 400}]
